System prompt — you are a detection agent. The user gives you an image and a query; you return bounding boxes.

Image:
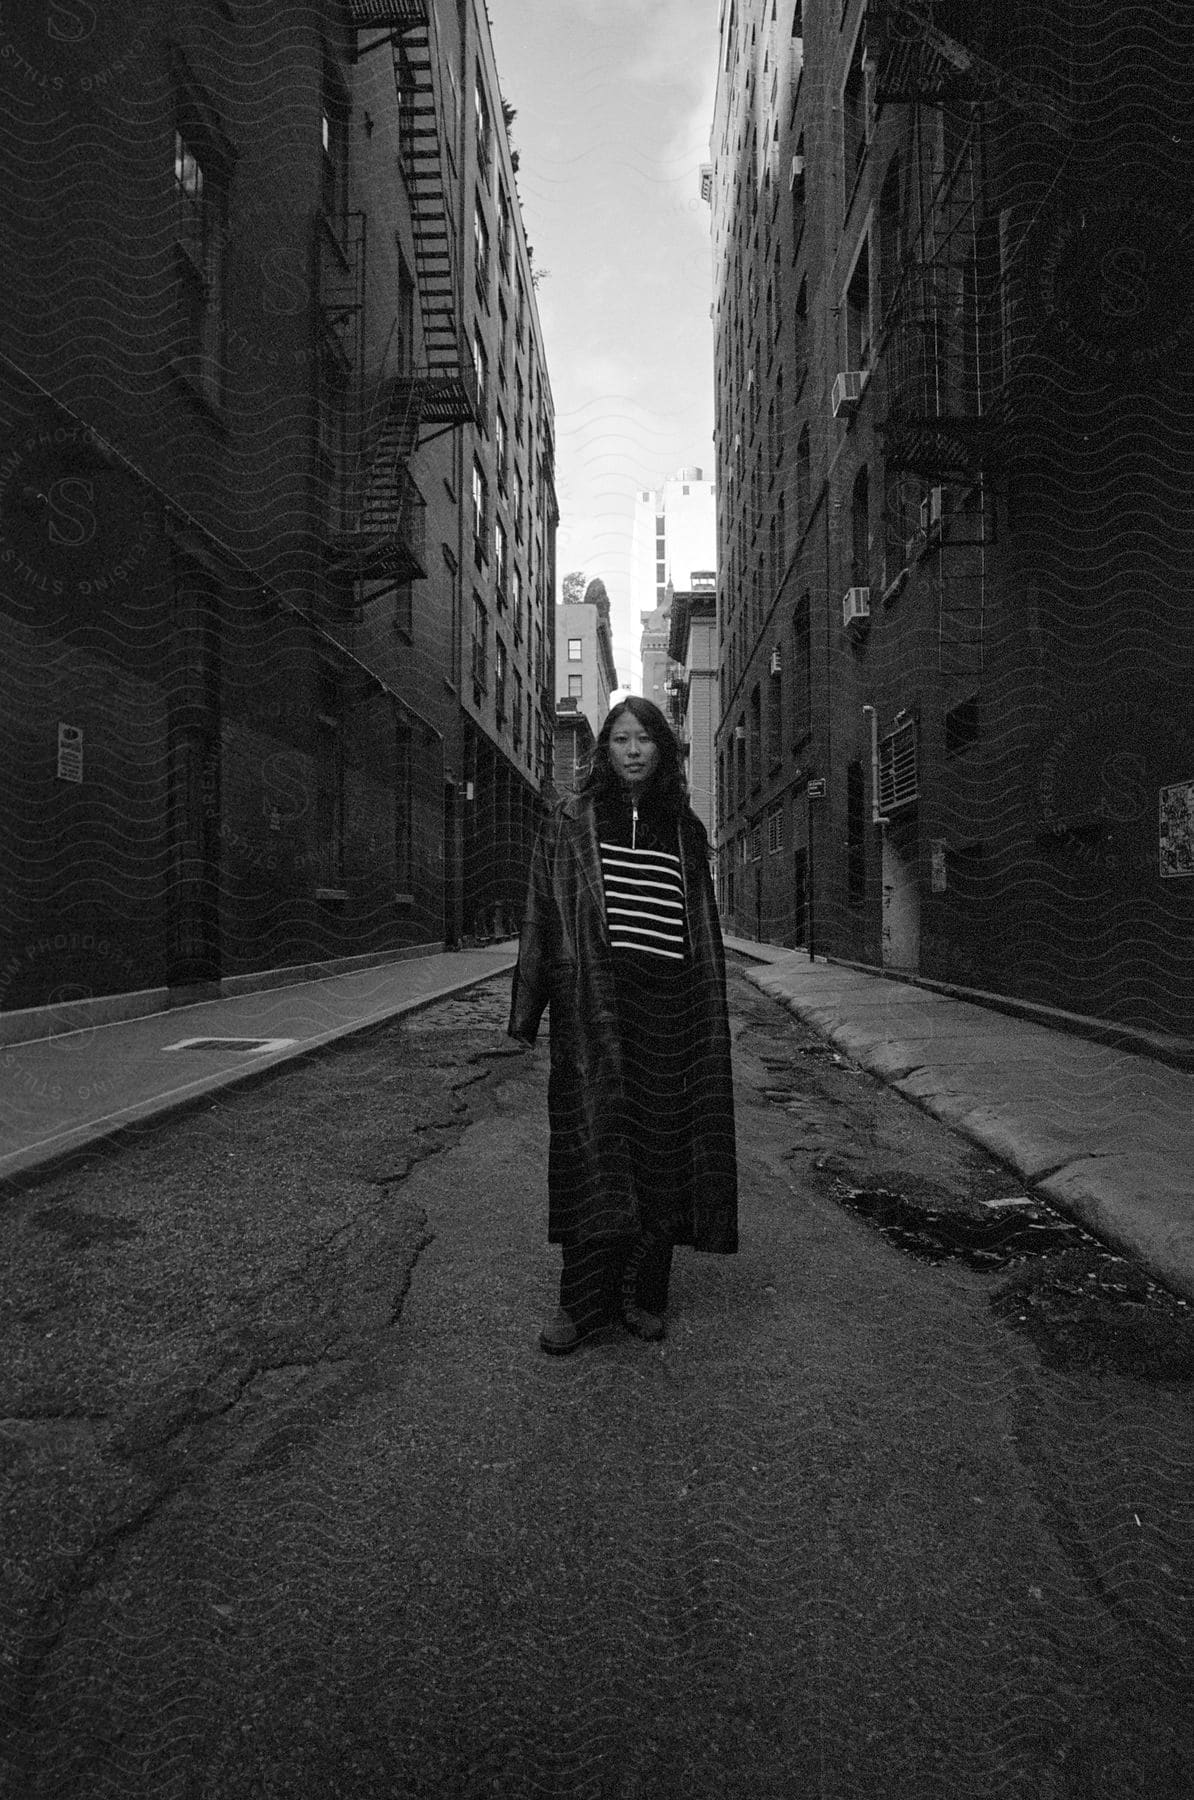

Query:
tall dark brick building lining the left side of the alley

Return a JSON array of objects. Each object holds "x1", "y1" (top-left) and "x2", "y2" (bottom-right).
[{"x1": 0, "y1": 0, "x2": 556, "y2": 1024}]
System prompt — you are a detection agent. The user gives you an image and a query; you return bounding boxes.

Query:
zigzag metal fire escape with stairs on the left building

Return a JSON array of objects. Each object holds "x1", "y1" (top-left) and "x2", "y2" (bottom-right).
[{"x1": 321, "y1": 0, "x2": 477, "y2": 590}]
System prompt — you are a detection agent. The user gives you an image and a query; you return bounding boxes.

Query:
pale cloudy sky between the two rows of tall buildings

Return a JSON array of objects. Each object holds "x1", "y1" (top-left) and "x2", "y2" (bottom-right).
[{"x1": 488, "y1": 0, "x2": 717, "y2": 686}]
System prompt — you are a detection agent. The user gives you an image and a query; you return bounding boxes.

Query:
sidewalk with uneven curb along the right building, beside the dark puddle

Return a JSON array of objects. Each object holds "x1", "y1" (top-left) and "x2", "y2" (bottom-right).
[{"x1": 726, "y1": 938, "x2": 1194, "y2": 1298}]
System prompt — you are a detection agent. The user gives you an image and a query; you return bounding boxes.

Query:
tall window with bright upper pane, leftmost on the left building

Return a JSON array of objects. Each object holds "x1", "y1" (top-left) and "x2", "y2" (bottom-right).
[{"x1": 175, "y1": 124, "x2": 229, "y2": 405}]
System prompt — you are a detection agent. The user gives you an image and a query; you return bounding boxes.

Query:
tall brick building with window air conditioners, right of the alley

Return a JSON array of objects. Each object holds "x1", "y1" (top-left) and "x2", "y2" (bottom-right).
[{"x1": 704, "y1": 0, "x2": 1194, "y2": 1033}]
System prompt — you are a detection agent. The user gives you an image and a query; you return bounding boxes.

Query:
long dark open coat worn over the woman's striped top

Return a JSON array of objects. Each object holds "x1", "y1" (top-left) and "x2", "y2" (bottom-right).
[{"x1": 510, "y1": 794, "x2": 738, "y2": 1253}]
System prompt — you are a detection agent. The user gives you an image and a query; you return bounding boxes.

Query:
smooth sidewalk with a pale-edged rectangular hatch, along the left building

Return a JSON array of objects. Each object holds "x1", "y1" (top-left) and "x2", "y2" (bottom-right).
[{"x1": 0, "y1": 943, "x2": 517, "y2": 1184}]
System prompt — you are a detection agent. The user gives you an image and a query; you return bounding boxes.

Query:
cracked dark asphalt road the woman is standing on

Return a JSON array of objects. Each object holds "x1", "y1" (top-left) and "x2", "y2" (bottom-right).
[{"x1": 0, "y1": 977, "x2": 1194, "y2": 1800}]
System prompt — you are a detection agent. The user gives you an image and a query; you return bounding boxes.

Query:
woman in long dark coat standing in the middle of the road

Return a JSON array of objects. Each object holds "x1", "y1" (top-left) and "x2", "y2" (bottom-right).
[{"x1": 510, "y1": 698, "x2": 738, "y2": 1355}]
